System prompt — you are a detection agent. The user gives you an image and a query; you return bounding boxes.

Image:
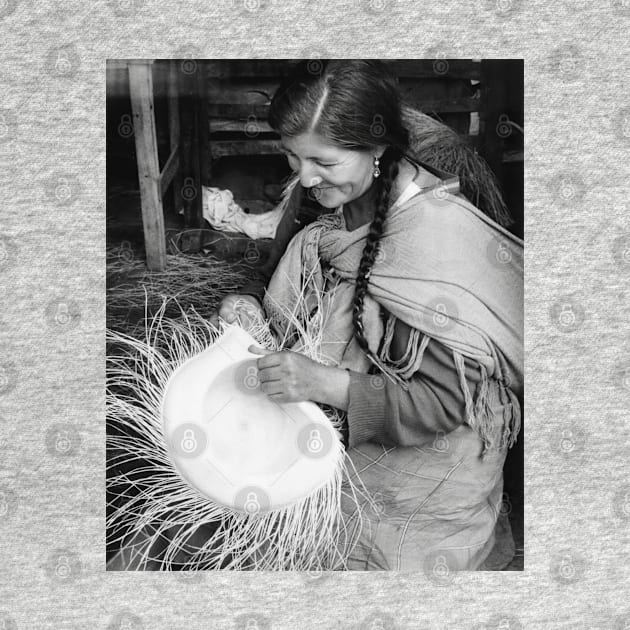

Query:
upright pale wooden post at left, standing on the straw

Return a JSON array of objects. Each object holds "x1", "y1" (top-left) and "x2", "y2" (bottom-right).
[{"x1": 129, "y1": 60, "x2": 166, "y2": 271}]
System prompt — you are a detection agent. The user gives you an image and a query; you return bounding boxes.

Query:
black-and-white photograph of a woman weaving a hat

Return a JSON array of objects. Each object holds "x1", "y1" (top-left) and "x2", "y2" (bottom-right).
[{"x1": 106, "y1": 61, "x2": 524, "y2": 576}]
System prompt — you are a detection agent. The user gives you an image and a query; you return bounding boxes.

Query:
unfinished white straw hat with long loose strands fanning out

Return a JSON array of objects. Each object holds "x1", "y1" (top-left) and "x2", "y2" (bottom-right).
[{"x1": 107, "y1": 303, "x2": 369, "y2": 571}]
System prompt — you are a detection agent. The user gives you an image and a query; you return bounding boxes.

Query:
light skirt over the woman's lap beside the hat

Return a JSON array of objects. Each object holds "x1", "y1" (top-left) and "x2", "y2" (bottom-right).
[{"x1": 342, "y1": 425, "x2": 506, "y2": 571}]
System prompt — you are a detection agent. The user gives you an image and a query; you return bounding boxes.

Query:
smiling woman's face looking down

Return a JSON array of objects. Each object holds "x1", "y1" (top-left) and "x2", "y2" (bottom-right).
[{"x1": 280, "y1": 132, "x2": 385, "y2": 208}]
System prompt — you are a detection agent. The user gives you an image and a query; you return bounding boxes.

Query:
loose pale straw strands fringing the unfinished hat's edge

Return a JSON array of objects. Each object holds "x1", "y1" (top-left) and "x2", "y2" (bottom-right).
[{"x1": 107, "y1": 288, "x2": 362, "y2": 570}]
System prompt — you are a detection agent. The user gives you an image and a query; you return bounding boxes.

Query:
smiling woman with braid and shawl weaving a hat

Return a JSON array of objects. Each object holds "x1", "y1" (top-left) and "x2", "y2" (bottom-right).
[{"x1": 221, "y1": 60, "x2": 523, "y2": 571}]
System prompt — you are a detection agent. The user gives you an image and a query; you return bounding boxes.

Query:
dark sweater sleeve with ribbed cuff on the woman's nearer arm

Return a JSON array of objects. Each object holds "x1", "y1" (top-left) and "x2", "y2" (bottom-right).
[{"x1": 348, "y1": 322, "x2": 481, "y2": 446}]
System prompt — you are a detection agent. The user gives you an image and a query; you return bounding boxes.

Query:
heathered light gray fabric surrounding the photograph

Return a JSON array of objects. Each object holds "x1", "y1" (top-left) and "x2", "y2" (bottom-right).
[{"x1": 0, "y1": 0, "x2": 630, "y2": 630}]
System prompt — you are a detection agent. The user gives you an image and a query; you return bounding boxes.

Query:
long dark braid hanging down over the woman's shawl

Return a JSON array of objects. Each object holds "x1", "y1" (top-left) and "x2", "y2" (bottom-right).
[{"x1": 352, "y1": 147, "x2": 402, "y2": 372}]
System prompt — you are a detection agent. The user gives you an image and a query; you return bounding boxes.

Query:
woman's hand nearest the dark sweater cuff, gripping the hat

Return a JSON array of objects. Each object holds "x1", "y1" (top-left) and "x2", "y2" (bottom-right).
[{"x1": 249, "y1": 346, "x2": 350, "y2": 409}]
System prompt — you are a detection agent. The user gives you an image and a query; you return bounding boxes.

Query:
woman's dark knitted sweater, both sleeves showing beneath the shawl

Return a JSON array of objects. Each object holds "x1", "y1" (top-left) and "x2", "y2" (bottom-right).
[{"x1": 241, "y1": 184, "x2": 480, "y2": 447}]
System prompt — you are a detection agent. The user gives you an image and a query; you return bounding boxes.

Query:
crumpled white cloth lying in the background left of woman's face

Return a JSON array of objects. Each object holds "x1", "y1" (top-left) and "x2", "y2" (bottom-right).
[{"x1": 202, "y1": 186, "x2": 284, "y2": 239}]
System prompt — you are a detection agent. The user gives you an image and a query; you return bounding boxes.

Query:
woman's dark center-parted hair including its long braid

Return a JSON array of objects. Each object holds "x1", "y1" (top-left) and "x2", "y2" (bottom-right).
[{"x1": 269, "y1": 59, "x2": 409, "y2": 364}]
